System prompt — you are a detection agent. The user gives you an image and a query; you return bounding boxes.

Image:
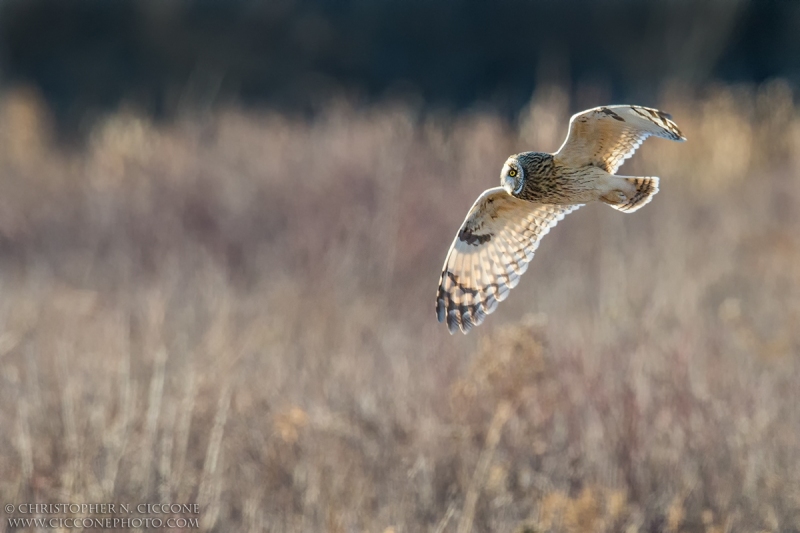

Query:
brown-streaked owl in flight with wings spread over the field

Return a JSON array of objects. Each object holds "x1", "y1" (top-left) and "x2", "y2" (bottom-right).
[{"x1": 436, "y1": 105, "x2": 686, "y2": 334}]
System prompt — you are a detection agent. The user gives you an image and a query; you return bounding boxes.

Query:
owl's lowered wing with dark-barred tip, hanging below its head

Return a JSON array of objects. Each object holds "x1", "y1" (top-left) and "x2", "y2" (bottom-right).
[{"x1": 436, "y1": 187, "x2": 582, "y2": 334}]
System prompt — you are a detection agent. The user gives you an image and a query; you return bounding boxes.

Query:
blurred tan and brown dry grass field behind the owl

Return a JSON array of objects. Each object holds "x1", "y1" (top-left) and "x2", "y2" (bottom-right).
[{"x1": 0, "y1": 81, "x2": 800, "y2": 533}]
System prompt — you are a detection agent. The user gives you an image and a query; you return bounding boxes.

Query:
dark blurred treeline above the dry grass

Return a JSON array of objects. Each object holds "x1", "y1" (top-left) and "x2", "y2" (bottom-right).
[{"x1": 0, "y1": 0, "x2": 800, "y2": 127}]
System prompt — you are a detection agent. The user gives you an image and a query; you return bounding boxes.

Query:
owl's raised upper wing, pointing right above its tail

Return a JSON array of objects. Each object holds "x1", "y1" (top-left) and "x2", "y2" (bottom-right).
[{"x1": 555, "y1": 105, "x2": 686, "y2": 174}]
